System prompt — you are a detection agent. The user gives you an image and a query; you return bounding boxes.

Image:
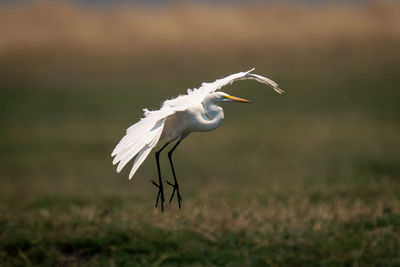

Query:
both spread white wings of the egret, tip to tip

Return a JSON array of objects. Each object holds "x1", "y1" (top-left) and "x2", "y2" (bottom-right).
[{"x1": 111, "y1": 68, "x2": 284, "y2": 179}]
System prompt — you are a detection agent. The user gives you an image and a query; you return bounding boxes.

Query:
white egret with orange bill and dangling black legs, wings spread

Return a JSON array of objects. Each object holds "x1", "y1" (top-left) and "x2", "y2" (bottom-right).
[{"x1": 111, "y1": 68, "x2": 284, "y2": 212}]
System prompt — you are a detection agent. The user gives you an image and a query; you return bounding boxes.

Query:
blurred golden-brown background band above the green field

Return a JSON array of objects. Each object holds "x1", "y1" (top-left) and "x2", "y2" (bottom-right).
[{"x1": 0, "y1": 1, "x2": 400, "y2": 86}]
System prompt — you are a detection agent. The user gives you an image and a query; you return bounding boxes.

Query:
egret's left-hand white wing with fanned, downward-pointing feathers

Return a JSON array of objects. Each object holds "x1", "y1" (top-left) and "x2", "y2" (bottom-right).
[{"x1": 111, "y1": 107, "x2": 174, "y2": 179}]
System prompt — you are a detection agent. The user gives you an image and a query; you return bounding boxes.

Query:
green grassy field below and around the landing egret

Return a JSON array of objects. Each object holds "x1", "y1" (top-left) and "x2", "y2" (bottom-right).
[{"x1": 0, "y1": 67, "x2": 400, "y2": 266}]
